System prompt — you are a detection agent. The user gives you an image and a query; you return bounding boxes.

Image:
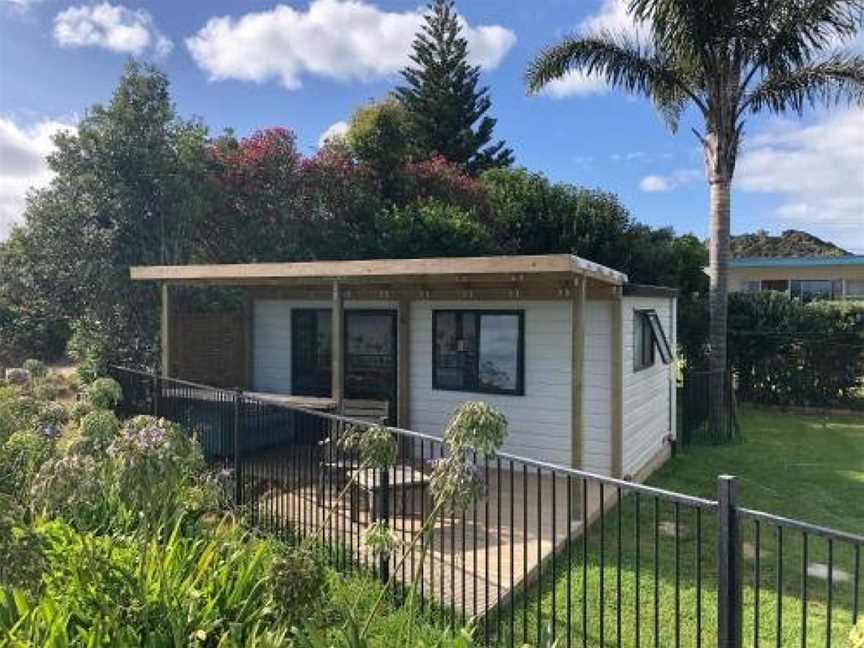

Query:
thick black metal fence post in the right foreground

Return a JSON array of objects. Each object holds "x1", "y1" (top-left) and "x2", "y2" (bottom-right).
[{"x1": 717, "y1": 475, "x2": 741, "y2": 648}]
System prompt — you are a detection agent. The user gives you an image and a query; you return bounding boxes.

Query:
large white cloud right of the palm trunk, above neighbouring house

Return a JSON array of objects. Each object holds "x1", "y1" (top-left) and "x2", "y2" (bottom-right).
[{"x1": 736, "y1": 108, "x2": 864, "y2": 250}]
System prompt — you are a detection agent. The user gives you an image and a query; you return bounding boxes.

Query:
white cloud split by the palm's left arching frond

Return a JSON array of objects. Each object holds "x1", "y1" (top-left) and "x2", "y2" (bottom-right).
[{"x1": 543, "y1": 0, "x2": 650, "y2": 99}]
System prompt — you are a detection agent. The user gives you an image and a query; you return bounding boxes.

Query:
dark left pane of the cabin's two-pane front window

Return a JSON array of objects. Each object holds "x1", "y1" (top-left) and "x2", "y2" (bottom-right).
[{"x1": 435, "y1": 311, "x2": 477, "y2": 389}]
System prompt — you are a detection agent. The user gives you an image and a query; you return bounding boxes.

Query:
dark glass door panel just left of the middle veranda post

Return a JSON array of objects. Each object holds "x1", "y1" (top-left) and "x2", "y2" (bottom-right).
[{"x1": 291, "y1": 308, "x2": 332, "y2": 397}]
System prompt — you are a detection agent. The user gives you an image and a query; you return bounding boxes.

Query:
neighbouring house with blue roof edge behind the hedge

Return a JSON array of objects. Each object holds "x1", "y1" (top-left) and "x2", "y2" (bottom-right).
[{"x1": 729, "y1": 255, "x2": 864, "y2": 300}]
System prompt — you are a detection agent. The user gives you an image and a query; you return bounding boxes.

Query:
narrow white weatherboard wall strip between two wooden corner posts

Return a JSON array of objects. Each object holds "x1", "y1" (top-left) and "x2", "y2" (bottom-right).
[{"x1": 582, "y1": 301, "x2": 614, "y2": 475}]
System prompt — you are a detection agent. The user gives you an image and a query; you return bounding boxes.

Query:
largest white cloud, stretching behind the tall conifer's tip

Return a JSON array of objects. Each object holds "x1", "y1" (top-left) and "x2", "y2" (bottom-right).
[{"x1": 186, "y1": 0, "x2": 516, "y2": 89}]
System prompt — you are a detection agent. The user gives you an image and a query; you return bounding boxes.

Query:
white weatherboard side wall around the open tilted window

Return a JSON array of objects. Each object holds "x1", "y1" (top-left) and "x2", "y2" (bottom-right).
[{"x1": 622, "y1": 297, "x2": 676, "y2": 475}]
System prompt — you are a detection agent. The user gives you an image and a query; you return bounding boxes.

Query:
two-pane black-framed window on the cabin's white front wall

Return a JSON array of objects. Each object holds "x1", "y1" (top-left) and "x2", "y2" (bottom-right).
[{"x1": 432, "y1": 310, "x2": 525, "y2": 395}]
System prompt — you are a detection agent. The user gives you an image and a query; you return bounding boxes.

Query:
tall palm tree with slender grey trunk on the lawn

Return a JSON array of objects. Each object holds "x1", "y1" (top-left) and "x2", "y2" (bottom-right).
[{"x1": 527, "y1": 0, "x2": 864, "y2": 435}]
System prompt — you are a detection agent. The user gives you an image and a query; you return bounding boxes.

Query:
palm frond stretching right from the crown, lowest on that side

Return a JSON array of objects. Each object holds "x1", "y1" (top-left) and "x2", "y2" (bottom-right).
[{"x1": 741, "y1": 54, "x2": 864, "y2": 113}]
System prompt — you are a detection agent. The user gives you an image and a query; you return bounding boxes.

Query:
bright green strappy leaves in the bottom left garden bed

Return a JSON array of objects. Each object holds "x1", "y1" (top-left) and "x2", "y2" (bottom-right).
[{"x1": 0, "y1": 521, "x2": 278, "y2": 648}]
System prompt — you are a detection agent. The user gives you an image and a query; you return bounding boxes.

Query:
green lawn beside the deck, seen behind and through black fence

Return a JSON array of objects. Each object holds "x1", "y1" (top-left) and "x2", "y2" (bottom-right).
[{"x1": 491, "y1": 408, "x2": 864, "y2": 648}]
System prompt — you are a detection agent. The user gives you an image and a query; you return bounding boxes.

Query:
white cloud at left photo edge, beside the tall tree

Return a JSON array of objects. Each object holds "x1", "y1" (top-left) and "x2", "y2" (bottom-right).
[{"x1": 0, "y1": 118, "x2": 74, "y2": 240}]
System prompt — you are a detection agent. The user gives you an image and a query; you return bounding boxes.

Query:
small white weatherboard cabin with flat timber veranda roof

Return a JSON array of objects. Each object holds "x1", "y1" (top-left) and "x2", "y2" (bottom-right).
[{"x1": 131, "y1": 254, "x2": 677, "y2": 479}]
